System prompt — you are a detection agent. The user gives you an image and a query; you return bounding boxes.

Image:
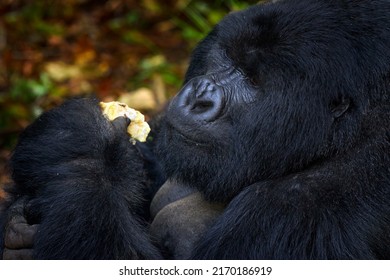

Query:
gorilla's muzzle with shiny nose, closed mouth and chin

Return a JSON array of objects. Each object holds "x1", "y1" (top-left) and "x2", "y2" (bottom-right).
[{"x1": 157, "y1": 76, "x2": 229, "y2": 174}]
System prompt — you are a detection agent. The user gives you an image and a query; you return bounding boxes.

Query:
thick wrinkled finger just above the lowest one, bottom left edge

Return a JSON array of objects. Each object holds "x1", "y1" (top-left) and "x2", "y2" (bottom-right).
[{"x1": 4, "y1": 221, "x2": 39, "y2": 249}]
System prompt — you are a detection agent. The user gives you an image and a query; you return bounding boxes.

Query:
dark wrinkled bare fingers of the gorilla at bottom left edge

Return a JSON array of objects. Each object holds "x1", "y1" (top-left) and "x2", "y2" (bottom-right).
[{"x1": 3, "y1": 199, "x2": 38, "y2": 260}]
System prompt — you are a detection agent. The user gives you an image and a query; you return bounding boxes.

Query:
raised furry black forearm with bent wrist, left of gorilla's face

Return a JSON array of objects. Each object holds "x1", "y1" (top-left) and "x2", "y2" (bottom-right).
[{"x1": 0, "y1": 99, "x2": 161, "y2": 259}]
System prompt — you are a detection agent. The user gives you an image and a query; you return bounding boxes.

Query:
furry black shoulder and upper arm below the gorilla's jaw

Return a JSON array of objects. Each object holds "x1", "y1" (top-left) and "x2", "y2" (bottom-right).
[{"x1": 191, "y1": 162, "x2": 390, "y2": 259}]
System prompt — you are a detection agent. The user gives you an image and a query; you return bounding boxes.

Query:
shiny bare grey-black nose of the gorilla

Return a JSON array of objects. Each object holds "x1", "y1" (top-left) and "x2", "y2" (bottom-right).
[{"x1": 170, "y1": 78, "x2": 224, "y2": 122}]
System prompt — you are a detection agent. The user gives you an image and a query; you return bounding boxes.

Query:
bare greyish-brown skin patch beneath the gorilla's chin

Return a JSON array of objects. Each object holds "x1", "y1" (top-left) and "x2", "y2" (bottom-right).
[{"x1": 150, "y1": 180, "x2": 224, "y2": 259}]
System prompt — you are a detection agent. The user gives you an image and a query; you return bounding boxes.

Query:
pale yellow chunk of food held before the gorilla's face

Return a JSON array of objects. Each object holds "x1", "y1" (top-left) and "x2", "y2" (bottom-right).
[{"x1": 99, "y1": 101, "x2": 150, "y2": 144}]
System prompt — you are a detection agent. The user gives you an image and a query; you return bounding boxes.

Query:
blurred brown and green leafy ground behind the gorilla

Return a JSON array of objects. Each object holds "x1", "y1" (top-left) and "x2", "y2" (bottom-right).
[{"x1": 0, "y1": 0, "x2": 261, "y2": 187}]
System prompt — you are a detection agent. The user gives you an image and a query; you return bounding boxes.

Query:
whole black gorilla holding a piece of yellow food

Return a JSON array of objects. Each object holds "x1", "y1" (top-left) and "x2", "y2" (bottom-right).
[{"x1": 0, "y1": 0, "x2": 390, "y2": 259}]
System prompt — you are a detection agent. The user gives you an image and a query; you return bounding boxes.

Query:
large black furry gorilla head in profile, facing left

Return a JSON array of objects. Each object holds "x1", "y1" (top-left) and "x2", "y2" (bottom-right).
[{"x1": 157, "y1": 0, "x2": 390, "y2": 200}]
